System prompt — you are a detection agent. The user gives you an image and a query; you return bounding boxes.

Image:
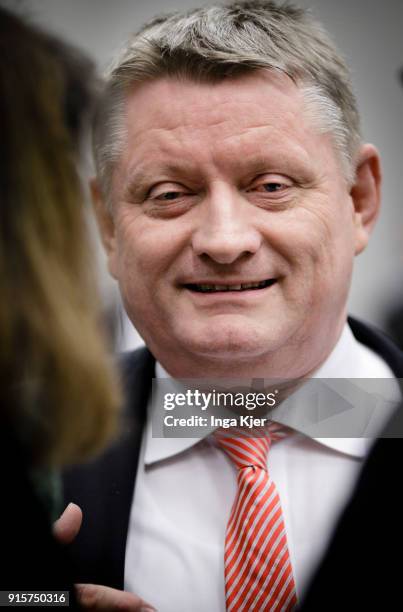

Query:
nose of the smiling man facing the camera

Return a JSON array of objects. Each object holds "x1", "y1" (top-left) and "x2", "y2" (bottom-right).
[{"x1": 192, "y1": 188, "x2": 261, "y2": 264}]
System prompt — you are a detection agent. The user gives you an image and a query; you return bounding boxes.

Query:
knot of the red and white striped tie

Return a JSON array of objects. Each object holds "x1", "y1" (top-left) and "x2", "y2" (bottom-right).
[{"x1": 214, "y1": 423, "x2": 281, "y2": 470}]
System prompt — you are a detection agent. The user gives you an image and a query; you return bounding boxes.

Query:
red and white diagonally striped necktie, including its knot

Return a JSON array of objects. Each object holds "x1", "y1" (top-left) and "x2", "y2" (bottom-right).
[{"x1": 214, "y1": 423, "x2": 297, "y2": 612}]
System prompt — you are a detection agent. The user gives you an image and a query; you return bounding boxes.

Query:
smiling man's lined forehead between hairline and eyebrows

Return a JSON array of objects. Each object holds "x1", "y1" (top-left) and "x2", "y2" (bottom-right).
[{"x1": 115, "y1": 70, "x2": 336, "y2": 184}]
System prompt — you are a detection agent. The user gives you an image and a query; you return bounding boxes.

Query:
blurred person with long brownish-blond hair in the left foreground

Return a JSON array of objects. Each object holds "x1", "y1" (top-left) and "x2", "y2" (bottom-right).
[{"x1": 0, "y1": 4, "x2": 120, "y2": 599}]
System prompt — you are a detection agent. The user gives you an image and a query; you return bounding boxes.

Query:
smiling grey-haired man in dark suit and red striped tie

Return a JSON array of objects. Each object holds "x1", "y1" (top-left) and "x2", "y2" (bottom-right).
[{"x1": 66, "y1": 2, "x2": 403, "y2": 611}]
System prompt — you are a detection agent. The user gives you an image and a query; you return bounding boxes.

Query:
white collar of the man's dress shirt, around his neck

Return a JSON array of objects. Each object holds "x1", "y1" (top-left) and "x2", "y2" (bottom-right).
[{"x1": 144, "y1": 323, "x2": 393, "y2": 465}]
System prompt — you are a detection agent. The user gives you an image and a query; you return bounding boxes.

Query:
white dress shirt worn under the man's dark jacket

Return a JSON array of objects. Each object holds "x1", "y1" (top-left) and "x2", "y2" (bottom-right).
[{"x1": 125, "y1": 324, "x2": 400, "y2": 612}]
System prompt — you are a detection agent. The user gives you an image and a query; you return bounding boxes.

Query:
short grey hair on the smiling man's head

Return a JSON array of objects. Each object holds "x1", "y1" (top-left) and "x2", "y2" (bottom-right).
[{"x1": 94, "y1": 0, "x2": 361, "y2": 205}]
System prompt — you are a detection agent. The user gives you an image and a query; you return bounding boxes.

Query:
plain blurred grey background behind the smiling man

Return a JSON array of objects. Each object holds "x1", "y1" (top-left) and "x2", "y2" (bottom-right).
[{"x1": 0, "y1": 0, "x2": 403, "y2": 350}]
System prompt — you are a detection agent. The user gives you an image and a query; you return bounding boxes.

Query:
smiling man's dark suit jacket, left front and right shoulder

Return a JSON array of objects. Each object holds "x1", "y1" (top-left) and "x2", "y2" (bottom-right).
[{"x1": 65, "y1": 320, "x2": 403, "y2": 589}]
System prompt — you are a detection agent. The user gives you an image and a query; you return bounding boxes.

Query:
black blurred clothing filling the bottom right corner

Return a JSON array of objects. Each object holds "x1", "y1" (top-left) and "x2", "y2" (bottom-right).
[{"x1": 300, "y1": 382, "x2": 403, "y2": 612}]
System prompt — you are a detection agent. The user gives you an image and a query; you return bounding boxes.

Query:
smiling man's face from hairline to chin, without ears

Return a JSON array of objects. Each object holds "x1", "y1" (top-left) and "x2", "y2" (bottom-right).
[{"x1": 100, "y1": 71, "x2": 378, "y2": 376}]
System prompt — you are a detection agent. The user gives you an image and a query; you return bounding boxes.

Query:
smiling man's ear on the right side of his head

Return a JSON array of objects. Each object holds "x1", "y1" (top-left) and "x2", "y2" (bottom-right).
[{"x1": 350, "y1": 144, "x2": 382, "y2": 255}]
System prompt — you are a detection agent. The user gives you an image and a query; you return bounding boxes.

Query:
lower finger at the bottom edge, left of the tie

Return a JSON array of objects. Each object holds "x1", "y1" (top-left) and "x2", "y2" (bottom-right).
[{"x1": 76, "y1": 584, "x2": 156, "y2": 612}]
